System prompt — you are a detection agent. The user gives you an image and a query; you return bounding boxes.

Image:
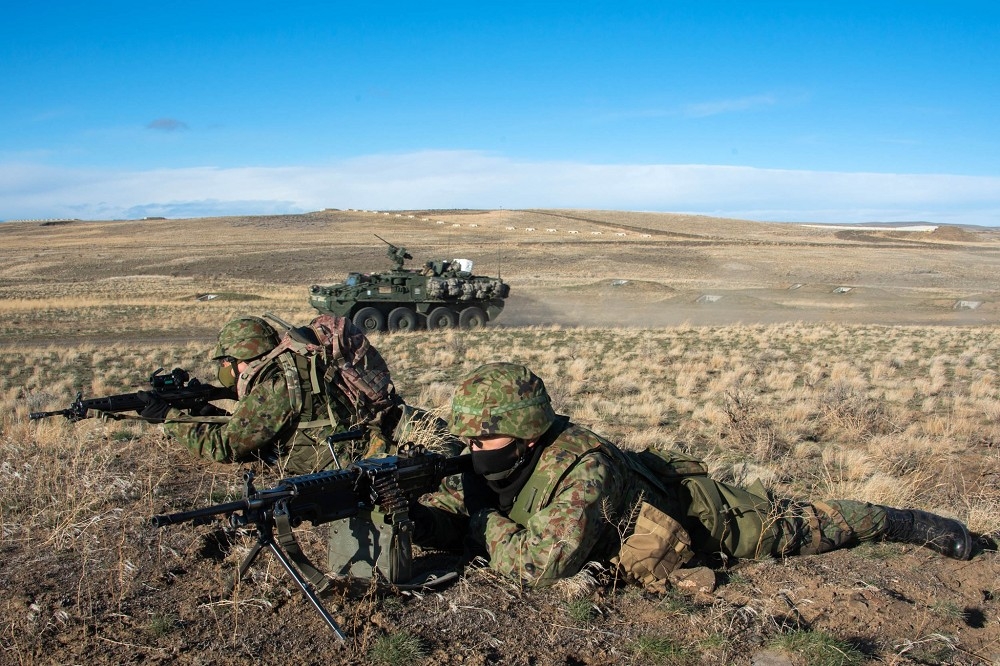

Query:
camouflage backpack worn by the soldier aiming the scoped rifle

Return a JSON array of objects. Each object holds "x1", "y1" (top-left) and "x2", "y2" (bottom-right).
[{"x1": 237, "y1": 315, "x2": 401, "y2": 428}]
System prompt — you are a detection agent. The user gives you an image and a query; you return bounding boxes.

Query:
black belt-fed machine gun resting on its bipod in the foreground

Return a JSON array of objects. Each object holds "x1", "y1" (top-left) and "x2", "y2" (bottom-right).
[{"x1": 150, "y1": 430, "x2": 472, "y2": 642}]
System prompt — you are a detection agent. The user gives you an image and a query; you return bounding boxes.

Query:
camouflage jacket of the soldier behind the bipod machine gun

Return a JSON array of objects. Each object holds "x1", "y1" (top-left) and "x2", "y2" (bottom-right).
[{"x1": 417, "y1": 424, "x2": 672, "y2": 585}]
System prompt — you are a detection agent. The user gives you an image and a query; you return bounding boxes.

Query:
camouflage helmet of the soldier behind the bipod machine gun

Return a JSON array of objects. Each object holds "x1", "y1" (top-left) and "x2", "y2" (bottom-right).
[{"x1": 448, "y1": 363, "x2": 556, "y2": 440}]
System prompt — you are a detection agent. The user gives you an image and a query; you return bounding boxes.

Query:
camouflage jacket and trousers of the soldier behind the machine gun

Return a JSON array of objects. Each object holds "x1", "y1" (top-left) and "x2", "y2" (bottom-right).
[{"x1": 413, "y1": 424, "x2": 886, "y2": 585}]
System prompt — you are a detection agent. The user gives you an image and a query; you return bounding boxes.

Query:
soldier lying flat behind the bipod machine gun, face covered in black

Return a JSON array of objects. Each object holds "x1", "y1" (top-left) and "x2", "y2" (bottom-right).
[{"x1": 411, "y1": 363, "x2": 972, "y2": 590}]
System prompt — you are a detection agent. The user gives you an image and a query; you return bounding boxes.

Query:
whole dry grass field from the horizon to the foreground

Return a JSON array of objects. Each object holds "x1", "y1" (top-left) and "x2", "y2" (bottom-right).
[{"x1": 0, "y1": 210, "x2": 1000, "y2": 666}]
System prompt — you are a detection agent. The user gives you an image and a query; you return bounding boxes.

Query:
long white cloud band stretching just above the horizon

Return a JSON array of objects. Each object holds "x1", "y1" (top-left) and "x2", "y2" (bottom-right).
[{"x1": 0, "y1": 151, "x2": 1000, "y2": 225}]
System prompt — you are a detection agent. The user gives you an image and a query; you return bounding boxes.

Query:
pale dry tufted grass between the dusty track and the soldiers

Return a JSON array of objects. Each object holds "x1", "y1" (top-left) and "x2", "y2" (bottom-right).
[{"x1": 0, "y1": 325, "x2": 1000, "y2": 564}]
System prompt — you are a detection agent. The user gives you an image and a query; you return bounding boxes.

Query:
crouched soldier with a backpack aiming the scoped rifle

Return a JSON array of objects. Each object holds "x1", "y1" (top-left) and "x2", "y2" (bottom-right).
[{"x1": 140, "y1": 316, "x2": 460, "y2": 474}]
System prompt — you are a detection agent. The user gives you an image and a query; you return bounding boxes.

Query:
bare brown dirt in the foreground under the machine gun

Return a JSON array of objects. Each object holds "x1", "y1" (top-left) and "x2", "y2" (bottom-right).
[{"x1": 0, "y1": 478, "x2": 1000, "y2": 666}]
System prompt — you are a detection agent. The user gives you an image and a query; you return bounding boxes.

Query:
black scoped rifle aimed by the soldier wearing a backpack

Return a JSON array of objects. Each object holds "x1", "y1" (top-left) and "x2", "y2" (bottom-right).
[{"x1": 28, "y1": 368, "x2": 236, "y2": 421}]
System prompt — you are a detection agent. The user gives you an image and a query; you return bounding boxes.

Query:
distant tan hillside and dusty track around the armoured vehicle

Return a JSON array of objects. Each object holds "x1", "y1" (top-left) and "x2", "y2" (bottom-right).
[{"x1": 0, "y1": 210, "x2": 1000, "y2": 338}]
